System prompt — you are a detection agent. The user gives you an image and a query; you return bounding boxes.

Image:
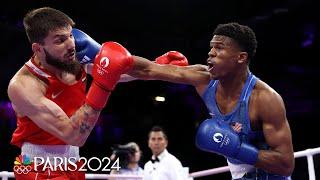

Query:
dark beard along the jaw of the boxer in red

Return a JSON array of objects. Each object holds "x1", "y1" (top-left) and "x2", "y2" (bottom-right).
[{"x1": 43, "y1": 49, "x2": 81, "y2": 75}]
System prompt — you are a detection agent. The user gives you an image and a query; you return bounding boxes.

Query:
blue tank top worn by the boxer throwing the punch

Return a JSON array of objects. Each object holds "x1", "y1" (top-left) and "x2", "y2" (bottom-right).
[{"x1": 202, "y1": 72, "x2": 268, "y2": 164}]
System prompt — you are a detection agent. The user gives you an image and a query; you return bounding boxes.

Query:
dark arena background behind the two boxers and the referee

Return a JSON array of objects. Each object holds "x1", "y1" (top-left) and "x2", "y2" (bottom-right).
[{"x1": 0, "y1": 0, "x2": 320, "y2": 180}]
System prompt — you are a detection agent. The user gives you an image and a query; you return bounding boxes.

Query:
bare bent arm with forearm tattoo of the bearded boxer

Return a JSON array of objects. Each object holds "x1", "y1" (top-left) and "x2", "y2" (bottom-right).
[{"x1": 8, "y1": 75, "x2": 100, "y2": 146}]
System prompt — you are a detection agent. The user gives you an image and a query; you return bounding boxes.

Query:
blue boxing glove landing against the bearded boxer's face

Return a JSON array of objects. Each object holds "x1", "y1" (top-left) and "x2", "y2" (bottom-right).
[{"x1": 72, "y1": 28, "x2": 101, "y2": 64}]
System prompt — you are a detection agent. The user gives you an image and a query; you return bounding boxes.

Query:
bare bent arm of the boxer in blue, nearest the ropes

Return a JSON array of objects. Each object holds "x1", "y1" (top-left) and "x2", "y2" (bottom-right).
[{"x1": 256, "y1": 90, "x2": 294, "y2": 175}]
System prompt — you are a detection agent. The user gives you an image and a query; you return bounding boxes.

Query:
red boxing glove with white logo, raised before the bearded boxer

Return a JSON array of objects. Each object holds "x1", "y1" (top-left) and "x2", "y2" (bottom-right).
[{"x1": 86, "y1": 42, "x2": 133, "y2": 110}]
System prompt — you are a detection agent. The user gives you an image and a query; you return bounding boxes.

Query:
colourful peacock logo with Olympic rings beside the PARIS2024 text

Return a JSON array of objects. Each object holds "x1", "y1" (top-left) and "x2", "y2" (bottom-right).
[{"x1": 13, "y1": 155, "x2": 32, "y2": 174}]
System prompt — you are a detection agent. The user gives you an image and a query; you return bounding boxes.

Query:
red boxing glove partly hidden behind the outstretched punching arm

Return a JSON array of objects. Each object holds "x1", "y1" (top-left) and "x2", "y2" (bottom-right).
[{"x1": 155, "y1": 51, "x2": 189, "y2": 66}]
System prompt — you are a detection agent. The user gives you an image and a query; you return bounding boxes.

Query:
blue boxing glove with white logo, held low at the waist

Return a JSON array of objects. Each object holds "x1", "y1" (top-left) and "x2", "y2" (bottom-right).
[{"x1": 196, "y1": 119, "x2": 258, "y2": 165}]
